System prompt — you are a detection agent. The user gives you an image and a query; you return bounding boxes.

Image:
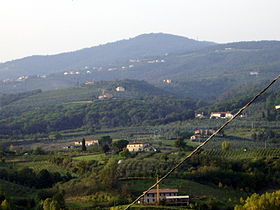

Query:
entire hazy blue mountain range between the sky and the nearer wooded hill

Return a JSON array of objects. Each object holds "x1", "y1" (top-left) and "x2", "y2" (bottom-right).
[{"x1": 0, "y1": 34, "x2": 280, "y2": 100}]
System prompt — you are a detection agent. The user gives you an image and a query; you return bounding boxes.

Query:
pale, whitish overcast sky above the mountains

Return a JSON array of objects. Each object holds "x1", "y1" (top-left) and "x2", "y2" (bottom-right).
[{"x1": 0, "y1": 0, "x2": 280, "y2": 62}]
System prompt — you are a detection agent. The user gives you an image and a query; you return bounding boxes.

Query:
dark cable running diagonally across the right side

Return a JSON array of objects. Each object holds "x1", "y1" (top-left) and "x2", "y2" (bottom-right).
[{"x1": 125, "y1": 74, "x2": 280, "y2": 210}]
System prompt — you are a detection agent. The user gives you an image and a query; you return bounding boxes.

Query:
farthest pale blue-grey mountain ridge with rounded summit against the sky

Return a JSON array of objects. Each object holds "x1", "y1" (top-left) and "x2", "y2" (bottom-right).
[{"x1": 0, "y1": 33, "x2": 215, "y2": 79}]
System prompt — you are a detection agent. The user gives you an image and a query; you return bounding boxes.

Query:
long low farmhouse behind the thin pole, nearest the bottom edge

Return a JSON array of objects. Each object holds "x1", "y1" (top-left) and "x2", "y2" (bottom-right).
[{"x1": 140, "y1": 189, "x2": 189, "y2": 205}]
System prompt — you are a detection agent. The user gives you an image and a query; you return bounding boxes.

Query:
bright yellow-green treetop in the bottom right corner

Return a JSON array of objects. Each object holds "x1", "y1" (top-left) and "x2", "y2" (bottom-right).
[{"x1": 234, "y1": 191, "x2": 280, "y2": 210}]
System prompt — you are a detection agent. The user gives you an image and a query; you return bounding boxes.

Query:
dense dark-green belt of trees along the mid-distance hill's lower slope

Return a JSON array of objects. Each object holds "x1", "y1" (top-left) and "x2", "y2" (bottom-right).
[{"x1": 0, "y1": 97, "x2": 197, "y2": 135}]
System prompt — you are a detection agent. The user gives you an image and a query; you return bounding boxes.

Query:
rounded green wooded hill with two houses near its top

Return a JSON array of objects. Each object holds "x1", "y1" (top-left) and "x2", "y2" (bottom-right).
[{"x1": 0, "y1": 80, "x2": 197, "y2": 135}]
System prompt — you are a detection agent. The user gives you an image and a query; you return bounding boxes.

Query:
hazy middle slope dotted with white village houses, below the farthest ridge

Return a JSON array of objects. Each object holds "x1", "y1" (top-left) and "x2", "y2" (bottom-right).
[{"x1": 0, "y1": 38, "x2": 280, "y2": 100}]
